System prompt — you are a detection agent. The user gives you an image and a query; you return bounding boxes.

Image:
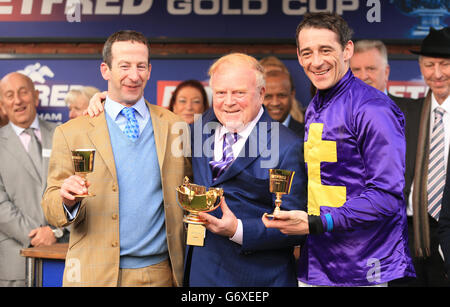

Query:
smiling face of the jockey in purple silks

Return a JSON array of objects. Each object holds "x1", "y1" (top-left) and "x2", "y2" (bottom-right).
[{"x1": 297, "y1": 27, "x2": 353, "y2": 90}]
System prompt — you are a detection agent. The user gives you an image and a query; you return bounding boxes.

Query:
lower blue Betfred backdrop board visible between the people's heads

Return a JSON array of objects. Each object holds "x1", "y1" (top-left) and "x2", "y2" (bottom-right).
[{"x1": 0, "y1": 59, "x2": 425, "y2": 122}]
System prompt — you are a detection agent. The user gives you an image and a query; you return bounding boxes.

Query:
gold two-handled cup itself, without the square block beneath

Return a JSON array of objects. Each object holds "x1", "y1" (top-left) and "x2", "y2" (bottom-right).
[{"x1": 176, "y1": 177, "x2": 223, "y2": 225}]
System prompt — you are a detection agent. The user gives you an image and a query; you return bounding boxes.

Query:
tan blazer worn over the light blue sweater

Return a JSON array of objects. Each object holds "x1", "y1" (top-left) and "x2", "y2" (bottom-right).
[{"x1": 42, "y1": 103, "x2": 191, "y2": 286}]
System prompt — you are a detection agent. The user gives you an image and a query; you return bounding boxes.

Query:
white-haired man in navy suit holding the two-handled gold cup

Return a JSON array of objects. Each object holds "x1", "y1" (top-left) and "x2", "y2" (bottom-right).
[{"x1": 186, "y1": 54, "x2": 306, "y2": 286}]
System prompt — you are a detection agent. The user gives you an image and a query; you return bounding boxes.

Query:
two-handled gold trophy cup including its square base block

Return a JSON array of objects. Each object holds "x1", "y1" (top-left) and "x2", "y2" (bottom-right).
[{"x1": 176, "y1": 177, "x2": 223, "y2": 246}]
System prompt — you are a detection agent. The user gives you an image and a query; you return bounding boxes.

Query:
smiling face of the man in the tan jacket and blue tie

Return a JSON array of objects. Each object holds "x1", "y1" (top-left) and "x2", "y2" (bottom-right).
[{"x1": 100, "y1": 41, "x2": 151, "y2": 106}]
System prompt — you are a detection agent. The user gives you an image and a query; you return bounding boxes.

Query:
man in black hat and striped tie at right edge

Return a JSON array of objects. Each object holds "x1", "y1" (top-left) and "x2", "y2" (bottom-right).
[{"x1": 411, "y1": 27, "x2": 450, "y2": 286}]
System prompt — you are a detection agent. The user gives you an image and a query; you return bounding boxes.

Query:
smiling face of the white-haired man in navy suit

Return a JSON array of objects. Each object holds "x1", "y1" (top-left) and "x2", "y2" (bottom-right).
[{"x1": 210, "y1": 61, "x2": 265, "y2": 132}]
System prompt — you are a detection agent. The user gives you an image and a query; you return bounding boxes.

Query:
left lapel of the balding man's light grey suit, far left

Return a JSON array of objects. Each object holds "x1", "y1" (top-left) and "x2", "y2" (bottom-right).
[{"x1": 2, "y1": 125, "x2": 42, "y2": 184}]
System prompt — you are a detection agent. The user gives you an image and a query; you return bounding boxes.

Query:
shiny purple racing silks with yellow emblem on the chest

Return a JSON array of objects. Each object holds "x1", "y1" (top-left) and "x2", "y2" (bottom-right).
[{"x1": 298, "y1": 70, "x2": 415, "y2": 286}]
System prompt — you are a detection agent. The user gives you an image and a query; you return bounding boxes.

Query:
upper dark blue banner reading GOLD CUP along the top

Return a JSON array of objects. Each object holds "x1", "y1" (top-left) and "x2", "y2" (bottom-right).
[{"x1": 0, "y1": 0, "x2": 450, "y2": 40}]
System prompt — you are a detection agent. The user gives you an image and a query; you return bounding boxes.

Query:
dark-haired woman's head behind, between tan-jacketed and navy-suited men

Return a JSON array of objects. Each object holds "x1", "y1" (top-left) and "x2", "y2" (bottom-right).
[{"x1": 169, "y1": 80, "x2": 209, "y2": 124}]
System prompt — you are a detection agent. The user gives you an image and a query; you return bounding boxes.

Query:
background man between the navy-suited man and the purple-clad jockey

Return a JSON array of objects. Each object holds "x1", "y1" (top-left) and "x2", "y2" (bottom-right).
[{"x1": 264, "y1": 70, "x2": 305, "y2": 139}]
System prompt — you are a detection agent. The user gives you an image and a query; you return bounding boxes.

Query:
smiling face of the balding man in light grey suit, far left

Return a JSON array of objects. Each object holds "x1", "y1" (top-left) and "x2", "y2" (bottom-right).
[{"x1": 0, "y1": 73, "x2": 39, "y2": 128}]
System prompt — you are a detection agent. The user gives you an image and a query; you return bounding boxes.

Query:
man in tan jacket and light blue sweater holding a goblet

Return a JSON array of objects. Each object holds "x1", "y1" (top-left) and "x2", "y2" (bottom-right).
[{"x1": 42, "y1": 31, "x2": 191, "y2": 286}]
